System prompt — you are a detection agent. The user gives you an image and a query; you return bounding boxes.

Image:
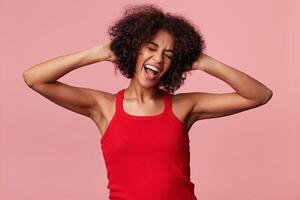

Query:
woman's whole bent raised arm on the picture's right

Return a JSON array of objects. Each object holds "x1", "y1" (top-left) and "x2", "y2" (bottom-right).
[{"x1": 187, "y1": 54, "x2": 273, "y2": 120}]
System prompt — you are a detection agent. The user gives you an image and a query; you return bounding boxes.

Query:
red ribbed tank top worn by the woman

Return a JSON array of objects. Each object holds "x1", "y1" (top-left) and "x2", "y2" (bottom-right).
[{"x1": 100, "y1": 89, "x2": 197, "y2": 200}]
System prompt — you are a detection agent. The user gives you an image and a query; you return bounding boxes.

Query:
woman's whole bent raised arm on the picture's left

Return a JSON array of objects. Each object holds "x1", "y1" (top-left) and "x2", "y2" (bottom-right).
[{"x1": 23, "y1": 43, "x2": 116, "y2": 117}]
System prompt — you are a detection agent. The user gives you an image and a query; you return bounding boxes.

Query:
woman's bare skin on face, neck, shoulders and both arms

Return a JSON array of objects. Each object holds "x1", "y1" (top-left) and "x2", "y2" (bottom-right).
[{"x1": 23, "y1": 30, "x2": 273, "y2": 136}]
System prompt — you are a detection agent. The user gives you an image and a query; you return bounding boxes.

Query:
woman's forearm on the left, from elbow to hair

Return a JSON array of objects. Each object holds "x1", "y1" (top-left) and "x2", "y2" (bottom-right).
[{"x1": 23, "y1": 45, "x2": 106, "y2": 85}]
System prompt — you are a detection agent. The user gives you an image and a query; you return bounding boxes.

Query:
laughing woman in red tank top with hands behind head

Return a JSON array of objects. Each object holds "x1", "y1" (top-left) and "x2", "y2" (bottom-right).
[{"x1": 24, "y1": 4, "x2": 272, "y2": 200}]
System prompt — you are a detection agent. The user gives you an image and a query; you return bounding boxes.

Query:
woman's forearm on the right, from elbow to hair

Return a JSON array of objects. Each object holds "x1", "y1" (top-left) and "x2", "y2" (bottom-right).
[{"x1": 193, "y1": 54, "x2": 272, "y2": 103}]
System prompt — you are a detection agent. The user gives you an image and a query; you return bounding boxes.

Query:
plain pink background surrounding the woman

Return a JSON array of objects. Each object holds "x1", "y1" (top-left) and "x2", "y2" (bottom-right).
[{"x1": 0, "y1": 0, "x2": 300, "y2": 200}]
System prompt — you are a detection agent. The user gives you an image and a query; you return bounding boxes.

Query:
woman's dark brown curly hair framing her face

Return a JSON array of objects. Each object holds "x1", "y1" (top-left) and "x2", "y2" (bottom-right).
[{"x1": 108, "y1": 4, "x2": 205, "y2": 94}]
